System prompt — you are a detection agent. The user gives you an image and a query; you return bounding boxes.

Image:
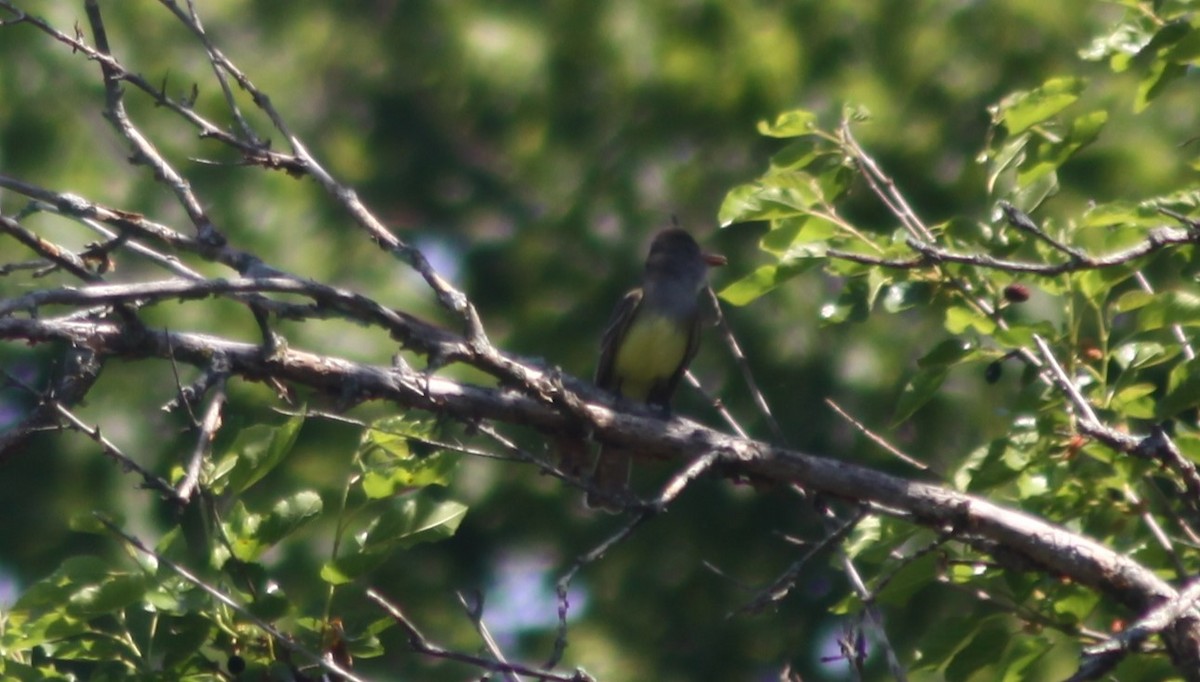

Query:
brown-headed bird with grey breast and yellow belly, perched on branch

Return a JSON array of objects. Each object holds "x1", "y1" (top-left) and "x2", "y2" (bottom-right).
[{"x1": 587, "y1": 228, "x2": 725, "y2": 510}]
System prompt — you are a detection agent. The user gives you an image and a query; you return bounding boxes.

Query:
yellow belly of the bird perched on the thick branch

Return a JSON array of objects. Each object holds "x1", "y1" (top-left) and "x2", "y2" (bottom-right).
[{"x1": 614, "y1": 313, "x2": 688, "y2": 401}]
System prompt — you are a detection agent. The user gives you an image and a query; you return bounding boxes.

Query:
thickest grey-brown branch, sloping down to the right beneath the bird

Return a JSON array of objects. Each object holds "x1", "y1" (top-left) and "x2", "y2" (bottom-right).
[{"x1": 0, "y1": 318, "x2": 1200, "y2": 629}]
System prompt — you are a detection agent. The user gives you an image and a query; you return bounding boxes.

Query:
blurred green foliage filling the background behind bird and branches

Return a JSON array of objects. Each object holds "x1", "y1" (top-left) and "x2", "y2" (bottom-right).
[{"x1": 0, "y1": 0, "x2": 1198, "y2": 681}]
